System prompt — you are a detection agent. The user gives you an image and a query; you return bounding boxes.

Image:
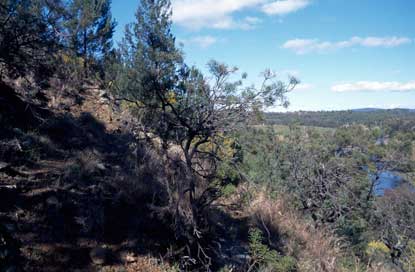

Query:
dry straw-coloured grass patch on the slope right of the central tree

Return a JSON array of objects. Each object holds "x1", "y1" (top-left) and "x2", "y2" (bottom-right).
[{"x1": 250, "y1": 190, "x2": 341, "y2": 272}]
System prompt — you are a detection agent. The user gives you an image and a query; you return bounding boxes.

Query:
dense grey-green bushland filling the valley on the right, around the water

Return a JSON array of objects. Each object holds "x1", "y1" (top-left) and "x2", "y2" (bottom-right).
[{"x1": 238, "y1": 125, "x2": 415, "y2": 271}]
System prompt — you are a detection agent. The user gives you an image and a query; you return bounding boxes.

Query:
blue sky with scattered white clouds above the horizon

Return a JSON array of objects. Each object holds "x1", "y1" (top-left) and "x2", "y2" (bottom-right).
[{"x1": 113, "y1": 0, "x2": 415, "y2": 111}]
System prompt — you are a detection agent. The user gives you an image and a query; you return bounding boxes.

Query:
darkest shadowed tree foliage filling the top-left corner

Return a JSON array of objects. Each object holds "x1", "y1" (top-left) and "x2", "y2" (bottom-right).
[{"x1": 0, "y1": 0, "x2": 60, "y2": 80}]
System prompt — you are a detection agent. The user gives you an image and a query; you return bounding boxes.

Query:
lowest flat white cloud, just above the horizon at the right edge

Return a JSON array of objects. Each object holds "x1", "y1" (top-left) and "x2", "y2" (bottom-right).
[{"x1": 331, "y1": 81, "x2": 415, "y2": 92}]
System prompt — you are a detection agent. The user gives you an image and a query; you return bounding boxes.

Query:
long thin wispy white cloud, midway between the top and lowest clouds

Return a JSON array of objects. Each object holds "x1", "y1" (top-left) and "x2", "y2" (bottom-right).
[{"x1": 282, "y1": 37, "x2": 412, "y2": 55}]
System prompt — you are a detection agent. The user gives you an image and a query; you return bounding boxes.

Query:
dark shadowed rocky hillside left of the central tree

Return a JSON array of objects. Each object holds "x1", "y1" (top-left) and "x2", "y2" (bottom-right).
[{"x1": 0, "y1": 84, "x2": 182, "y2": 271}]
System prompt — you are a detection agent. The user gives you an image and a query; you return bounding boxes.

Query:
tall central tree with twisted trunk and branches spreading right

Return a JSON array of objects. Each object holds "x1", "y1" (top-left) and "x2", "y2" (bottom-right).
[{"x1": 117, "y1": 0, "x2": 298, "y2": 266}]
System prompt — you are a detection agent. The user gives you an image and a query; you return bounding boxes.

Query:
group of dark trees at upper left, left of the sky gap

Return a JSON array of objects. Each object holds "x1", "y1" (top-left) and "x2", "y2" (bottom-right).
[{"x1": 0, "y1": 0, "x2": 115, "y2": 84}]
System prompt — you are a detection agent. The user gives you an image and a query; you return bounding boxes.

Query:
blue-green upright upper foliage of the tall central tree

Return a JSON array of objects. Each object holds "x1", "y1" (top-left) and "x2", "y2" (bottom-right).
[{"x1": 118, "y1": 0, "x2": 183, "y2": 104}]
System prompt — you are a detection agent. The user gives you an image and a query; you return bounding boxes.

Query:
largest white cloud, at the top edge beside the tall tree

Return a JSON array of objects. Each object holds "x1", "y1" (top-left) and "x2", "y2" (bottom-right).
[{"x1": 172, "y1": 0, "x2": 310, "y2": 30}]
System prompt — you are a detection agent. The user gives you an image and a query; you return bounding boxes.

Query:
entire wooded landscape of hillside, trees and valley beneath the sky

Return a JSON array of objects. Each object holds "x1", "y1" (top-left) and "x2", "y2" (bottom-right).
[{"x1": 0, "y1": 0, "x2": 415, "y2": 272}]
